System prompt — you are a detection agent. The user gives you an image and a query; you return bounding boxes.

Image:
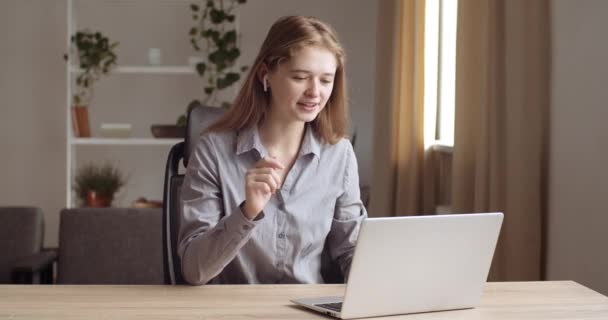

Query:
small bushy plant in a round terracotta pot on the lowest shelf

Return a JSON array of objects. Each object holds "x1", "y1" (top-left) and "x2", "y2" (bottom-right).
[{"x1": 73, "y1": 163, "x2": 126, "y2": 208}]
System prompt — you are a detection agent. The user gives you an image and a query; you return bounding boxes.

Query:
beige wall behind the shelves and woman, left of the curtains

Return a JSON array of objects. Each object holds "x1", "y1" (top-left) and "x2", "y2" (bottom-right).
[{"x1": 0, "y1": 0, "x2": 377, "y2": 246}]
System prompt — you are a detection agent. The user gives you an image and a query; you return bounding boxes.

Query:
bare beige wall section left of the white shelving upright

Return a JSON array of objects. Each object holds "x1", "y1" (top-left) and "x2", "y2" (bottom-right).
[{"x1": 0, "y1": 0, "x2": 66, "y2": 245}]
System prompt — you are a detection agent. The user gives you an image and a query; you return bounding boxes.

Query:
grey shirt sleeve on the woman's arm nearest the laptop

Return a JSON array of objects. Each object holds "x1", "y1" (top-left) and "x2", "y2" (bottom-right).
[{"x1": 328, "y1": 143, "x2": 367, "y2": 278}]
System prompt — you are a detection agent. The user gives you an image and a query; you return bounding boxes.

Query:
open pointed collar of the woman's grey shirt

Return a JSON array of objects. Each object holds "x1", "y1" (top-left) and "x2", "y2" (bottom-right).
[{"x1": 236, "y1": 124, "x2": 321, "y2": 158}]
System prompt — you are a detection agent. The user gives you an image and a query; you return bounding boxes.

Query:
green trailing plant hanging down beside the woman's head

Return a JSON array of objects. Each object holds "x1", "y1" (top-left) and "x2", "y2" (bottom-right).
[{"x1": 177, "y1": 0, "x2": 248, "y2": 126}]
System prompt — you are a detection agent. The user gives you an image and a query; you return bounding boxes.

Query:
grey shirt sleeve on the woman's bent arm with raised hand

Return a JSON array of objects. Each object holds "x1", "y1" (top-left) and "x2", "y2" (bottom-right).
[{"x1": 178, "y1": 135, "x2": 259, "y2": 285}]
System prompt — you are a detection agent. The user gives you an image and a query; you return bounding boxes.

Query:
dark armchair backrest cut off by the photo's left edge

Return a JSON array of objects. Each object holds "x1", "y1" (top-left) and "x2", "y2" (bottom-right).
[{"x1": 0, "y1": 207, "x2": 44, "y2": 283}]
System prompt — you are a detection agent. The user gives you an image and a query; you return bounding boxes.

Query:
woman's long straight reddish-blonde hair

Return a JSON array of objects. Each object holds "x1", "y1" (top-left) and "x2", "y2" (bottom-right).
[{"x1": 207, "y1": 16, "x2": 348, "y2": 144}]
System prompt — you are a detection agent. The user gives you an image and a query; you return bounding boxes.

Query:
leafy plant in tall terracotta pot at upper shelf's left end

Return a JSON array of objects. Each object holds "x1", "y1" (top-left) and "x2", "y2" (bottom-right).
[{"x1": 64, "y1": 30, "x2": 118, "y2": 137}]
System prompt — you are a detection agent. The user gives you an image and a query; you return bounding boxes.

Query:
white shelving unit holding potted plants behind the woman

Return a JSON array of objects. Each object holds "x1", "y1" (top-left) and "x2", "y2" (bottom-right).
[{"x1": 66, "y1": 0, "x2": 197, "y2": 208}]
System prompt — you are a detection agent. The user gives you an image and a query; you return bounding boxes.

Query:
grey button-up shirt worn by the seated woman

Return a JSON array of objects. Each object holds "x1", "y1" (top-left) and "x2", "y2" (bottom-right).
[{"x1": 178, "y1": 125, "x2": 367, "y2": 284}]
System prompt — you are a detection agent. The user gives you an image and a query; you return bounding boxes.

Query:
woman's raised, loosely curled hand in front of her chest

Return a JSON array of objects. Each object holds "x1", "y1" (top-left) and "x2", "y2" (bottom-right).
[{"x1": 241, "y1": 158, "x2": 284, "y2": 220}]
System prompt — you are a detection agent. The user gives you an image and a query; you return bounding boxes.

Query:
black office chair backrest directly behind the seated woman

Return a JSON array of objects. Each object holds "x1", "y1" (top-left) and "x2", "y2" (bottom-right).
[{"x1": 162, "y1": 104, "x2": 224, "y2": 284}]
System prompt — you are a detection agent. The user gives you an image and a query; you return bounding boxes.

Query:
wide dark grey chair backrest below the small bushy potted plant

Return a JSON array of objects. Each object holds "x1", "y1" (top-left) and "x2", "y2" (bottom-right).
[{"x1": 57, "y1": 208, "x2": 164, "y2": 284}]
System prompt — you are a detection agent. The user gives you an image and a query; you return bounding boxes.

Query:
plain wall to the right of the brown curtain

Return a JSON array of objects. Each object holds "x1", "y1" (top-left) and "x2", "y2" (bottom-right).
[{"x1": 547, "y1": 0, "x2": 608, "y2": 294}]
